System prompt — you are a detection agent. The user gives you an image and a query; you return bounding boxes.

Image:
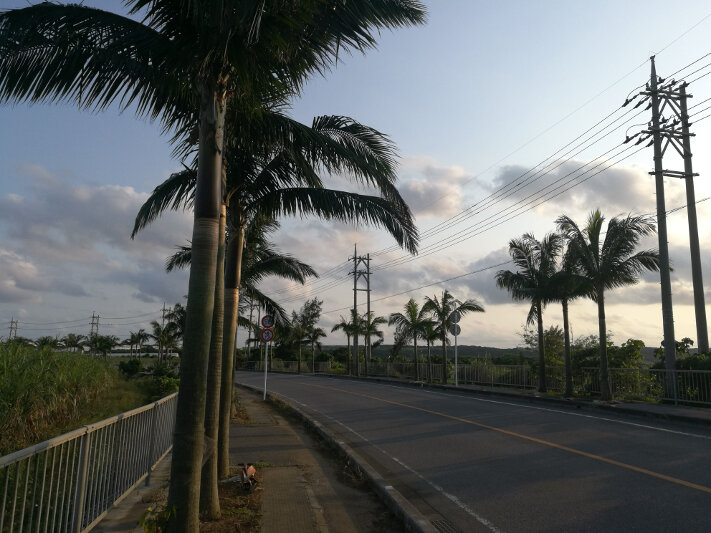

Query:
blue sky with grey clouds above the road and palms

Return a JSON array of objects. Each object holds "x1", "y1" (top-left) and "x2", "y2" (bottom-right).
[{"x1": 0, "y1": 0, "x2": 711, "y2": 347}]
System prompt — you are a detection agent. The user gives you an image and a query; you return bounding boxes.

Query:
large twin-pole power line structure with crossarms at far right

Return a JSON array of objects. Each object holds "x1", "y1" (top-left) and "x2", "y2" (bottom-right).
[{"x1": 641, "y1": 57, "x2": 709, "y2": 360}]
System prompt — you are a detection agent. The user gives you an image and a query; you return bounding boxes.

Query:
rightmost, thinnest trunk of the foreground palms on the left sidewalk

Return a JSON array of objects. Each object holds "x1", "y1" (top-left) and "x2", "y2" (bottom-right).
[{"x1": 217, "y1": 224, "x2": 246, "y2": 479}]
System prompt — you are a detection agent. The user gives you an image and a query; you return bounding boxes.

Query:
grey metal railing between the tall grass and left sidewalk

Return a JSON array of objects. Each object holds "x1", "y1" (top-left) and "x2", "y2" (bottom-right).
[{"x1": 0, "y1": 393, "x2": 178, "y2": 533}]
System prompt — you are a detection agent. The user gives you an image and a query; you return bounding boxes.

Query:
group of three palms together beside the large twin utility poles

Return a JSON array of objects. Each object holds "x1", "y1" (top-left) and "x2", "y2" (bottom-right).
[{"x1": 496, "y1": 209, "x2": 659, "y2": 401}]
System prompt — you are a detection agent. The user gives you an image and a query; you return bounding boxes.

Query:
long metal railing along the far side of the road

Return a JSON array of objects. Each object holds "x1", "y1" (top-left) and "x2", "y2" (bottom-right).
[{"x1": 243, "y1": 359, "x2": 711, "y2": 406}]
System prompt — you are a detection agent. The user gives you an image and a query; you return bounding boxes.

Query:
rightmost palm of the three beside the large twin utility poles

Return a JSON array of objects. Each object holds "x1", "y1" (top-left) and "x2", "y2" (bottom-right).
[{"x1": 556, "y1": 209, "x2": 659, "y2": 401}]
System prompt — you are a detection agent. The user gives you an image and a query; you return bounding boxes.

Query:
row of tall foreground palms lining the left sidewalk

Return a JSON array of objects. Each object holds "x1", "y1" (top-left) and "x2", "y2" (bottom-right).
[{"x1": 0, "y1": 0, "x2": 425, "y2": 532}]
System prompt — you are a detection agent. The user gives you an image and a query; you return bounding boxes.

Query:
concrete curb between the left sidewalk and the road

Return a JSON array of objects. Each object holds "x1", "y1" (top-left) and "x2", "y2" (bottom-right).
[{"x1": 236, "y1": 383, "x2": 438, "y2": 533}]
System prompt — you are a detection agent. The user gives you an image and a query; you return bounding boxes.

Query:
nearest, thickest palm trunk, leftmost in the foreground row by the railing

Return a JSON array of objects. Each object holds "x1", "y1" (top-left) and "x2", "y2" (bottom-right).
[{"x1": 168, "y1": 80, "x2": 225, "y2": 533}]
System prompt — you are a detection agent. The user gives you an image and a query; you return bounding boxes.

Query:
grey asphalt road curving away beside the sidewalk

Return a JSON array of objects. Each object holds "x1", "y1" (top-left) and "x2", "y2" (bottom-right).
[{"x1": 237, "y1": 372, "x2": 711, "y2": 533}]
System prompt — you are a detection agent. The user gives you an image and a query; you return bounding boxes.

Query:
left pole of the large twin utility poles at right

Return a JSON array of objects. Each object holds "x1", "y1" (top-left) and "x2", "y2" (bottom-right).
[{"x1": 643, "y1": 56, "x2": 677, "y2": 400}]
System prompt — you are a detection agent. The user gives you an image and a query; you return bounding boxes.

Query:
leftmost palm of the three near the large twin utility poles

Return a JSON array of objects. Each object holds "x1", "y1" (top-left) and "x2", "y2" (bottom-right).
[{"x1": 496, "y1": 233, "x2": 563, "y2": 392}]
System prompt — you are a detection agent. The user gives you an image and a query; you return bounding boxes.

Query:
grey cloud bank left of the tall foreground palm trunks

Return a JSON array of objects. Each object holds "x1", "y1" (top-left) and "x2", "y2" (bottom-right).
[{"x1": 0, "y1": 165, "x2": 192, "y2": 312}]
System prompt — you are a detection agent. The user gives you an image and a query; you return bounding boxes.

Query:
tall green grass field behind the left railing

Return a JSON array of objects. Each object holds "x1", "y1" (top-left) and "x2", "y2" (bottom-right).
[{"x1": 0, "y1": 342, "x2": 145, "y2": 456}]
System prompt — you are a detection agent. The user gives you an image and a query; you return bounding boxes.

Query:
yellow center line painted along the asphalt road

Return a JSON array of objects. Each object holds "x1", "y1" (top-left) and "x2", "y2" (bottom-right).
[{"x1": 310, "y1": 385, "x2": 711, "y2": 494}]
